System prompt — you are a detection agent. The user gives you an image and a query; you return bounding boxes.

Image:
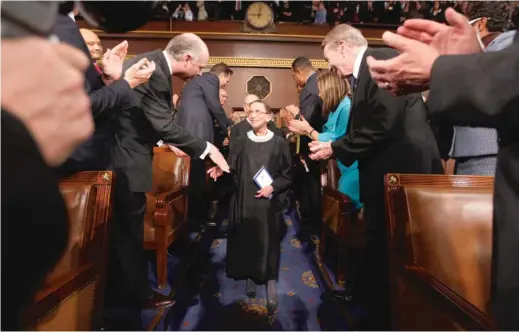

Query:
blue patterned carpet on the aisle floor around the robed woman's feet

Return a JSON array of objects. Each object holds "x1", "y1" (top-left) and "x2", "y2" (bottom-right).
[{"x1": 135, "y1": 209, "x2": 354, "y2": 331}]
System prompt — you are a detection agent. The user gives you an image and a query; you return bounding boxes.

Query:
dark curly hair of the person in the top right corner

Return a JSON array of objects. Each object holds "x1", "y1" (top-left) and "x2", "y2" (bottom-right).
[{"x1": 468, "y1": 1, "x2": 510, "y2": 32}]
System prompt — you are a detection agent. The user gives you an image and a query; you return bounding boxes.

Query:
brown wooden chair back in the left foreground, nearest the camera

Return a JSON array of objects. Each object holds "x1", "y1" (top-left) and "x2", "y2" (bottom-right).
[{"x1": 19, "y1": 171, "x2": 113, "y2": 331}]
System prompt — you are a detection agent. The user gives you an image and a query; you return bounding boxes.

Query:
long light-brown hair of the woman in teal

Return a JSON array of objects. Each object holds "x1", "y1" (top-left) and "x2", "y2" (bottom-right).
[{"x1": 317, "y1": 71, "x2": 350, "y2": 116}]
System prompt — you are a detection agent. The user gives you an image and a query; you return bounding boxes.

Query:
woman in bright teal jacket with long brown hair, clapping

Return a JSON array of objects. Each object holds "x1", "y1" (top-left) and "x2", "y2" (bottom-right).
[{"x1": 288, "y1": 71, "x2": 362, "y2": 209}]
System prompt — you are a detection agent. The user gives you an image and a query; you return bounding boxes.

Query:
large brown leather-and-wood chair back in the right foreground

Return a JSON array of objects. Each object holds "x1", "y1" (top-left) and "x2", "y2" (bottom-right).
[{"x1": 385, "y1": 174, "x2": 494, "y2": 330}]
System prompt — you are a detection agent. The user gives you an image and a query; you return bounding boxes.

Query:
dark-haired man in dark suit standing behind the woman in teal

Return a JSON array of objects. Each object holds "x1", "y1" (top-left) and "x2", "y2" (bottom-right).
[{"x1": 285, "y1": 57, "x2": 324, "y2": 235}]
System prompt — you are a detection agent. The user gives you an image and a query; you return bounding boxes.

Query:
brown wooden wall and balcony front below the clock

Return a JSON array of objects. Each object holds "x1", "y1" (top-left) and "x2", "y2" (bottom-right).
[{"x1": 78, "y1": 19, "x2": 394, "y2": 112}]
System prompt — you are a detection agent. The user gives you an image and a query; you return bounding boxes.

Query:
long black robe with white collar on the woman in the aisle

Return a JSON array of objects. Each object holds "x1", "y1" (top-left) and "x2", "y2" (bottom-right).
[{"x1": 227, "y1": 131, "x2": 292, "y2": 284}]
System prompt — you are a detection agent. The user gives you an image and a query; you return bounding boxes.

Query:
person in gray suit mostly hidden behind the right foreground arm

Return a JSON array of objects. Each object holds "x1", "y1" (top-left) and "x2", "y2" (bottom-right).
[{"x1": 450, "y1": 2, "x2": 516, "y2": 176}]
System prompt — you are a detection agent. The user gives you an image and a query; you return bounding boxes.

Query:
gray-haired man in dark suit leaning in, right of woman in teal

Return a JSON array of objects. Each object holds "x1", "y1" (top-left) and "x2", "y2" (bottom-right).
[{"x1": 310, "y1": 24, "x2": 443, "y2": 330}]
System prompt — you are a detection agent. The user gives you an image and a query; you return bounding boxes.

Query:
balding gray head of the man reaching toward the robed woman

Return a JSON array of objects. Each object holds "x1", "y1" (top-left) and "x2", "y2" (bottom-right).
[{"x1": 164, "y1": 33, "x2": 209, "y2": 79}]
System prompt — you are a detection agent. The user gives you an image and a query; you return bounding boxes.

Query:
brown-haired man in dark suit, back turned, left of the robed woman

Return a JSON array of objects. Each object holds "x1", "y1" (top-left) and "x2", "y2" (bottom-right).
[{"x1": 175, "y1": 63, "x2": 233, "y2": 229}]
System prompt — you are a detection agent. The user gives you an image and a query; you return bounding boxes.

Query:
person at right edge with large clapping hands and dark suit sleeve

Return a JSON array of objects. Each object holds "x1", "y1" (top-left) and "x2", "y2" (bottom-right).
[{"x1": 368, "y1": 8, "x2": 519, "y2": 330}]
